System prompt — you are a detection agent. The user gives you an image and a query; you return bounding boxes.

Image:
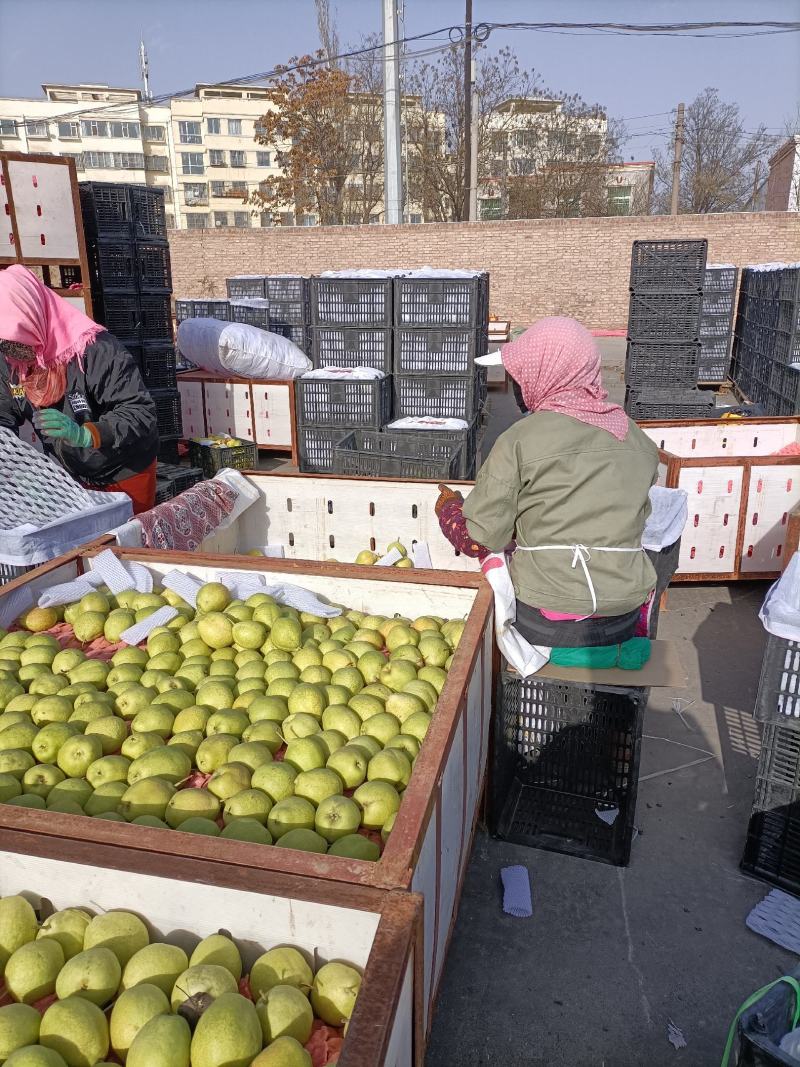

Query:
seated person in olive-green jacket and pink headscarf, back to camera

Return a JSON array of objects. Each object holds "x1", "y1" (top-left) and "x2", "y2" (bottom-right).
[{"x1": 436, "y1": 318, "x2": 658, "y2": 648}]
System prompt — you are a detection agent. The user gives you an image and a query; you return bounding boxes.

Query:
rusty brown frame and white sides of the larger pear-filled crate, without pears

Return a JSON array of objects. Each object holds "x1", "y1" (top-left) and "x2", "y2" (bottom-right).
[{"x1": 0, "y1": 535, "x2": 494, "y2": 1029}]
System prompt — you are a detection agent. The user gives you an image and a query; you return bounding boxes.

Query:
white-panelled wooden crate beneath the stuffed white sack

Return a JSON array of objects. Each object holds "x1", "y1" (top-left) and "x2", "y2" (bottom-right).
[{"x1": 178, "y1": 371, "x2": 298, "y2": 466}]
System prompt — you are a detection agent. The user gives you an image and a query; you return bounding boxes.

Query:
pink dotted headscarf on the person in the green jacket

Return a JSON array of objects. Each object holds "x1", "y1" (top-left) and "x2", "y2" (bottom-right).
[{"x1": 502, "y1": 317, "x2": 628, "y2": 441}]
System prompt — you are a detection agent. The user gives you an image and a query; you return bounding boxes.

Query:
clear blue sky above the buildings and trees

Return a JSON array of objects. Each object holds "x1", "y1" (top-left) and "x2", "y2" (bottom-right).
[{"x1": 0, "y1": 0, "x2": 800, "y2": 159}]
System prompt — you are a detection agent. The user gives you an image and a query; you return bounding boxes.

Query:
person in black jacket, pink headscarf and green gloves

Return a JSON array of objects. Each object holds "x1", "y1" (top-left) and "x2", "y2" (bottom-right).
[{"x1": 0, "y1": 265, "x2": 158, "y2": 514}]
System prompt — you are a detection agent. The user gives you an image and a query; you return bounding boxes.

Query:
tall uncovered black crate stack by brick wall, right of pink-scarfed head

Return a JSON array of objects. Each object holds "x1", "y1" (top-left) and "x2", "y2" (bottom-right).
[{"x1": 625, "y1": 241, "x2": 714, "y2": 419}]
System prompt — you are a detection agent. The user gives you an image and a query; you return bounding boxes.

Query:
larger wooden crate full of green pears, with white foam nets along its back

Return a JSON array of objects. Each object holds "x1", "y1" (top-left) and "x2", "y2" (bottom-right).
[{"x1": 0, "y1": 535, "x2": 494, "y2": 1033}]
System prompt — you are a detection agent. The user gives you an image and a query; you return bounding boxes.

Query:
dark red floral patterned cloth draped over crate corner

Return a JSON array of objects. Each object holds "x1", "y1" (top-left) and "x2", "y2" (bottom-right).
[{"x1": 138, "y1": 479, "x2": 236, "y2": 552}]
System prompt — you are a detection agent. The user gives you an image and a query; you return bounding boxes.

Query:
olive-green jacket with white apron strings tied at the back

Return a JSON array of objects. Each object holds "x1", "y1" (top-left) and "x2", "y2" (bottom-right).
[{"x1": 464, "y1": 412, "x2": 658, "y2": 616}]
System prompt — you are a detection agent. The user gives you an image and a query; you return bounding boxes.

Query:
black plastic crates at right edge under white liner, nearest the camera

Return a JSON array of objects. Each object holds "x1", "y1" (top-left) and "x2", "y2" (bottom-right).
[{"x1": 741, "y1": 634, "x2": 800, "y2": 894}]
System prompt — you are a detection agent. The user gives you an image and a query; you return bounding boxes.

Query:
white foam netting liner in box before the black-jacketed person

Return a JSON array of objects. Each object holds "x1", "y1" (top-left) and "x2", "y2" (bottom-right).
[{"x1": 0, "y1": 429, "x2": 133, "y2": 567}]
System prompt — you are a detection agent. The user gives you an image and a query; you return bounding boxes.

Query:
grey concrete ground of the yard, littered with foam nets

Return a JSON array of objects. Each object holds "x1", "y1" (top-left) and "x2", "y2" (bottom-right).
[{"x1": 426, "y1": 339, "x2": 797, "y2": 1067}]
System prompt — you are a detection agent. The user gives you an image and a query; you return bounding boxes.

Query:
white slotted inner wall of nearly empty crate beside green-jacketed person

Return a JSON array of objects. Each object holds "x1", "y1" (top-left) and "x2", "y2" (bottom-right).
[{"x1": 193, "y1": 471, "x2": 480, "y2": 573}]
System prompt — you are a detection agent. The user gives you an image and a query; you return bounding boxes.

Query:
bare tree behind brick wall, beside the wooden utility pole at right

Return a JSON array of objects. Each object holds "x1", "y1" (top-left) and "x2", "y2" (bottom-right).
[{"x1": 654, "y1": 89, "x2": 775, "y2": 214}]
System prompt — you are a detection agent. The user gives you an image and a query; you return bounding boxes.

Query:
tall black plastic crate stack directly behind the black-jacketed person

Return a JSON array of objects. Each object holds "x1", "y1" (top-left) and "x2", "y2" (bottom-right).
[{"x1": 80, "y1": 181, "x2": 181, "y2": 462}]
